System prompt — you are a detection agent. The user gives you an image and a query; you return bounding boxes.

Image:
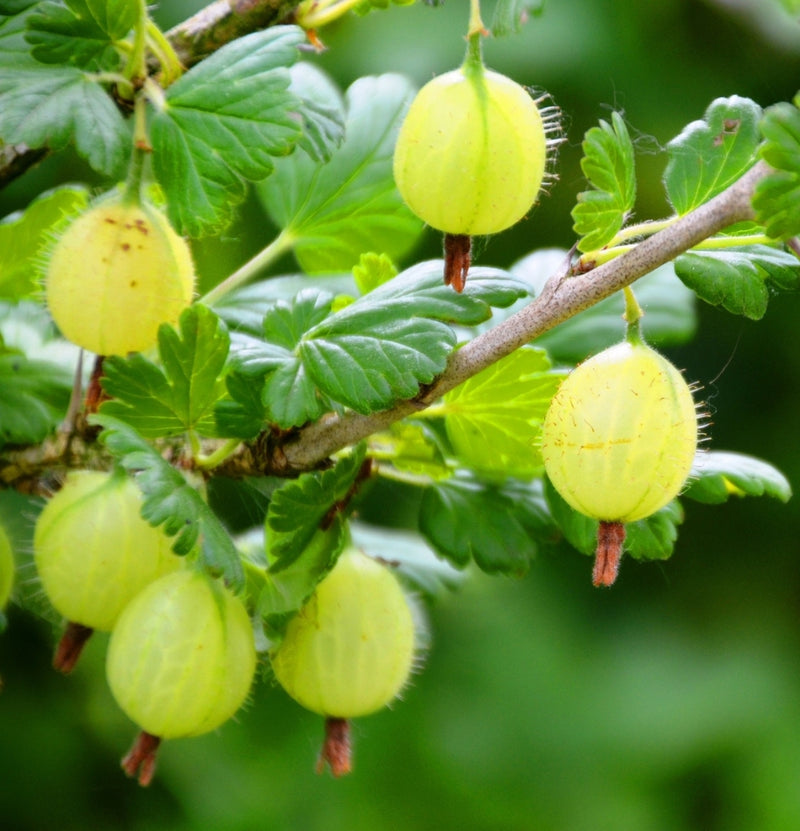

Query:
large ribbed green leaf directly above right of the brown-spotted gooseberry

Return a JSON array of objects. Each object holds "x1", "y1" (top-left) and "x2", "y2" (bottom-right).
[{"x1": 150, "y1": 26, "x2": 305, "y2": 236}]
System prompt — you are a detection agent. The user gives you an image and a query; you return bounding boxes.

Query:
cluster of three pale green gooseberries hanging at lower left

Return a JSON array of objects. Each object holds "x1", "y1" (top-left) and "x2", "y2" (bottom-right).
[{"x1": 25, "y1": 470, "x2": 416, "y2": 785}]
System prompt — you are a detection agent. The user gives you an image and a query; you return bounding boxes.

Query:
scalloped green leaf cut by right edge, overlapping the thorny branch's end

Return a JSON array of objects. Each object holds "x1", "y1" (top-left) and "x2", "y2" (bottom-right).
[{"x1": 753, "y1": 96, "x2": 800, "y2": 239}]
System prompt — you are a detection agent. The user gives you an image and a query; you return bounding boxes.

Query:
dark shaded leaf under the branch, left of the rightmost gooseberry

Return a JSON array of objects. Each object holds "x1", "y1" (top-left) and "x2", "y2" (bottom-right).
[{"x1": 419, "y1": 479, "x2": 538, "y2": 576}]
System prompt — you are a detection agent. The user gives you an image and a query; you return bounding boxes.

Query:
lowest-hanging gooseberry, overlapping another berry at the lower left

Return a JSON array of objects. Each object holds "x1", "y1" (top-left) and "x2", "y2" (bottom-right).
[{"x1": 106, "y1": 568, "x2": 256, "y2": 785}]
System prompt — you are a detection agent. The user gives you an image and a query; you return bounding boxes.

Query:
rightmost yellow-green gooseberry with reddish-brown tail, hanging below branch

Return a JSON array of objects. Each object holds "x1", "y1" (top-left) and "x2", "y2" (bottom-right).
[{"x1": 542, "y1": 339, "x2": 698, "y2": 585}]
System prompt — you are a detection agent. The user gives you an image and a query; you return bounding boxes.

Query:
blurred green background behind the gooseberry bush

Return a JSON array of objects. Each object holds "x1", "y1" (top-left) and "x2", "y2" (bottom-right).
[{"x1": 0, "y1": 0, "x2": 800, "y2": 831}]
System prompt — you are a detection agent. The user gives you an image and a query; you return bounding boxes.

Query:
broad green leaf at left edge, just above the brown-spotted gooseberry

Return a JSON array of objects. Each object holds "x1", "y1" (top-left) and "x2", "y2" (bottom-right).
[{"x1": 0, "y1": 65, "x2": 131, "y2": 176}]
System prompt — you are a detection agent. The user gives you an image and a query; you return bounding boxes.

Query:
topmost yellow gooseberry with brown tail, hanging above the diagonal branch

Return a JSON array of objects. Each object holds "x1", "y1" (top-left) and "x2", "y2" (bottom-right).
[{"x1": 394, "y1": 56, "x2": 548, "y2": 291}]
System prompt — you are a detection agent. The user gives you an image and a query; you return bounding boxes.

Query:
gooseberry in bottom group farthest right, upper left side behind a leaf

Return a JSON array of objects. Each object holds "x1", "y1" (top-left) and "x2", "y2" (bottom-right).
[{"x1": 271, "y1": 547, "x2": 415, "y2": 775}]
